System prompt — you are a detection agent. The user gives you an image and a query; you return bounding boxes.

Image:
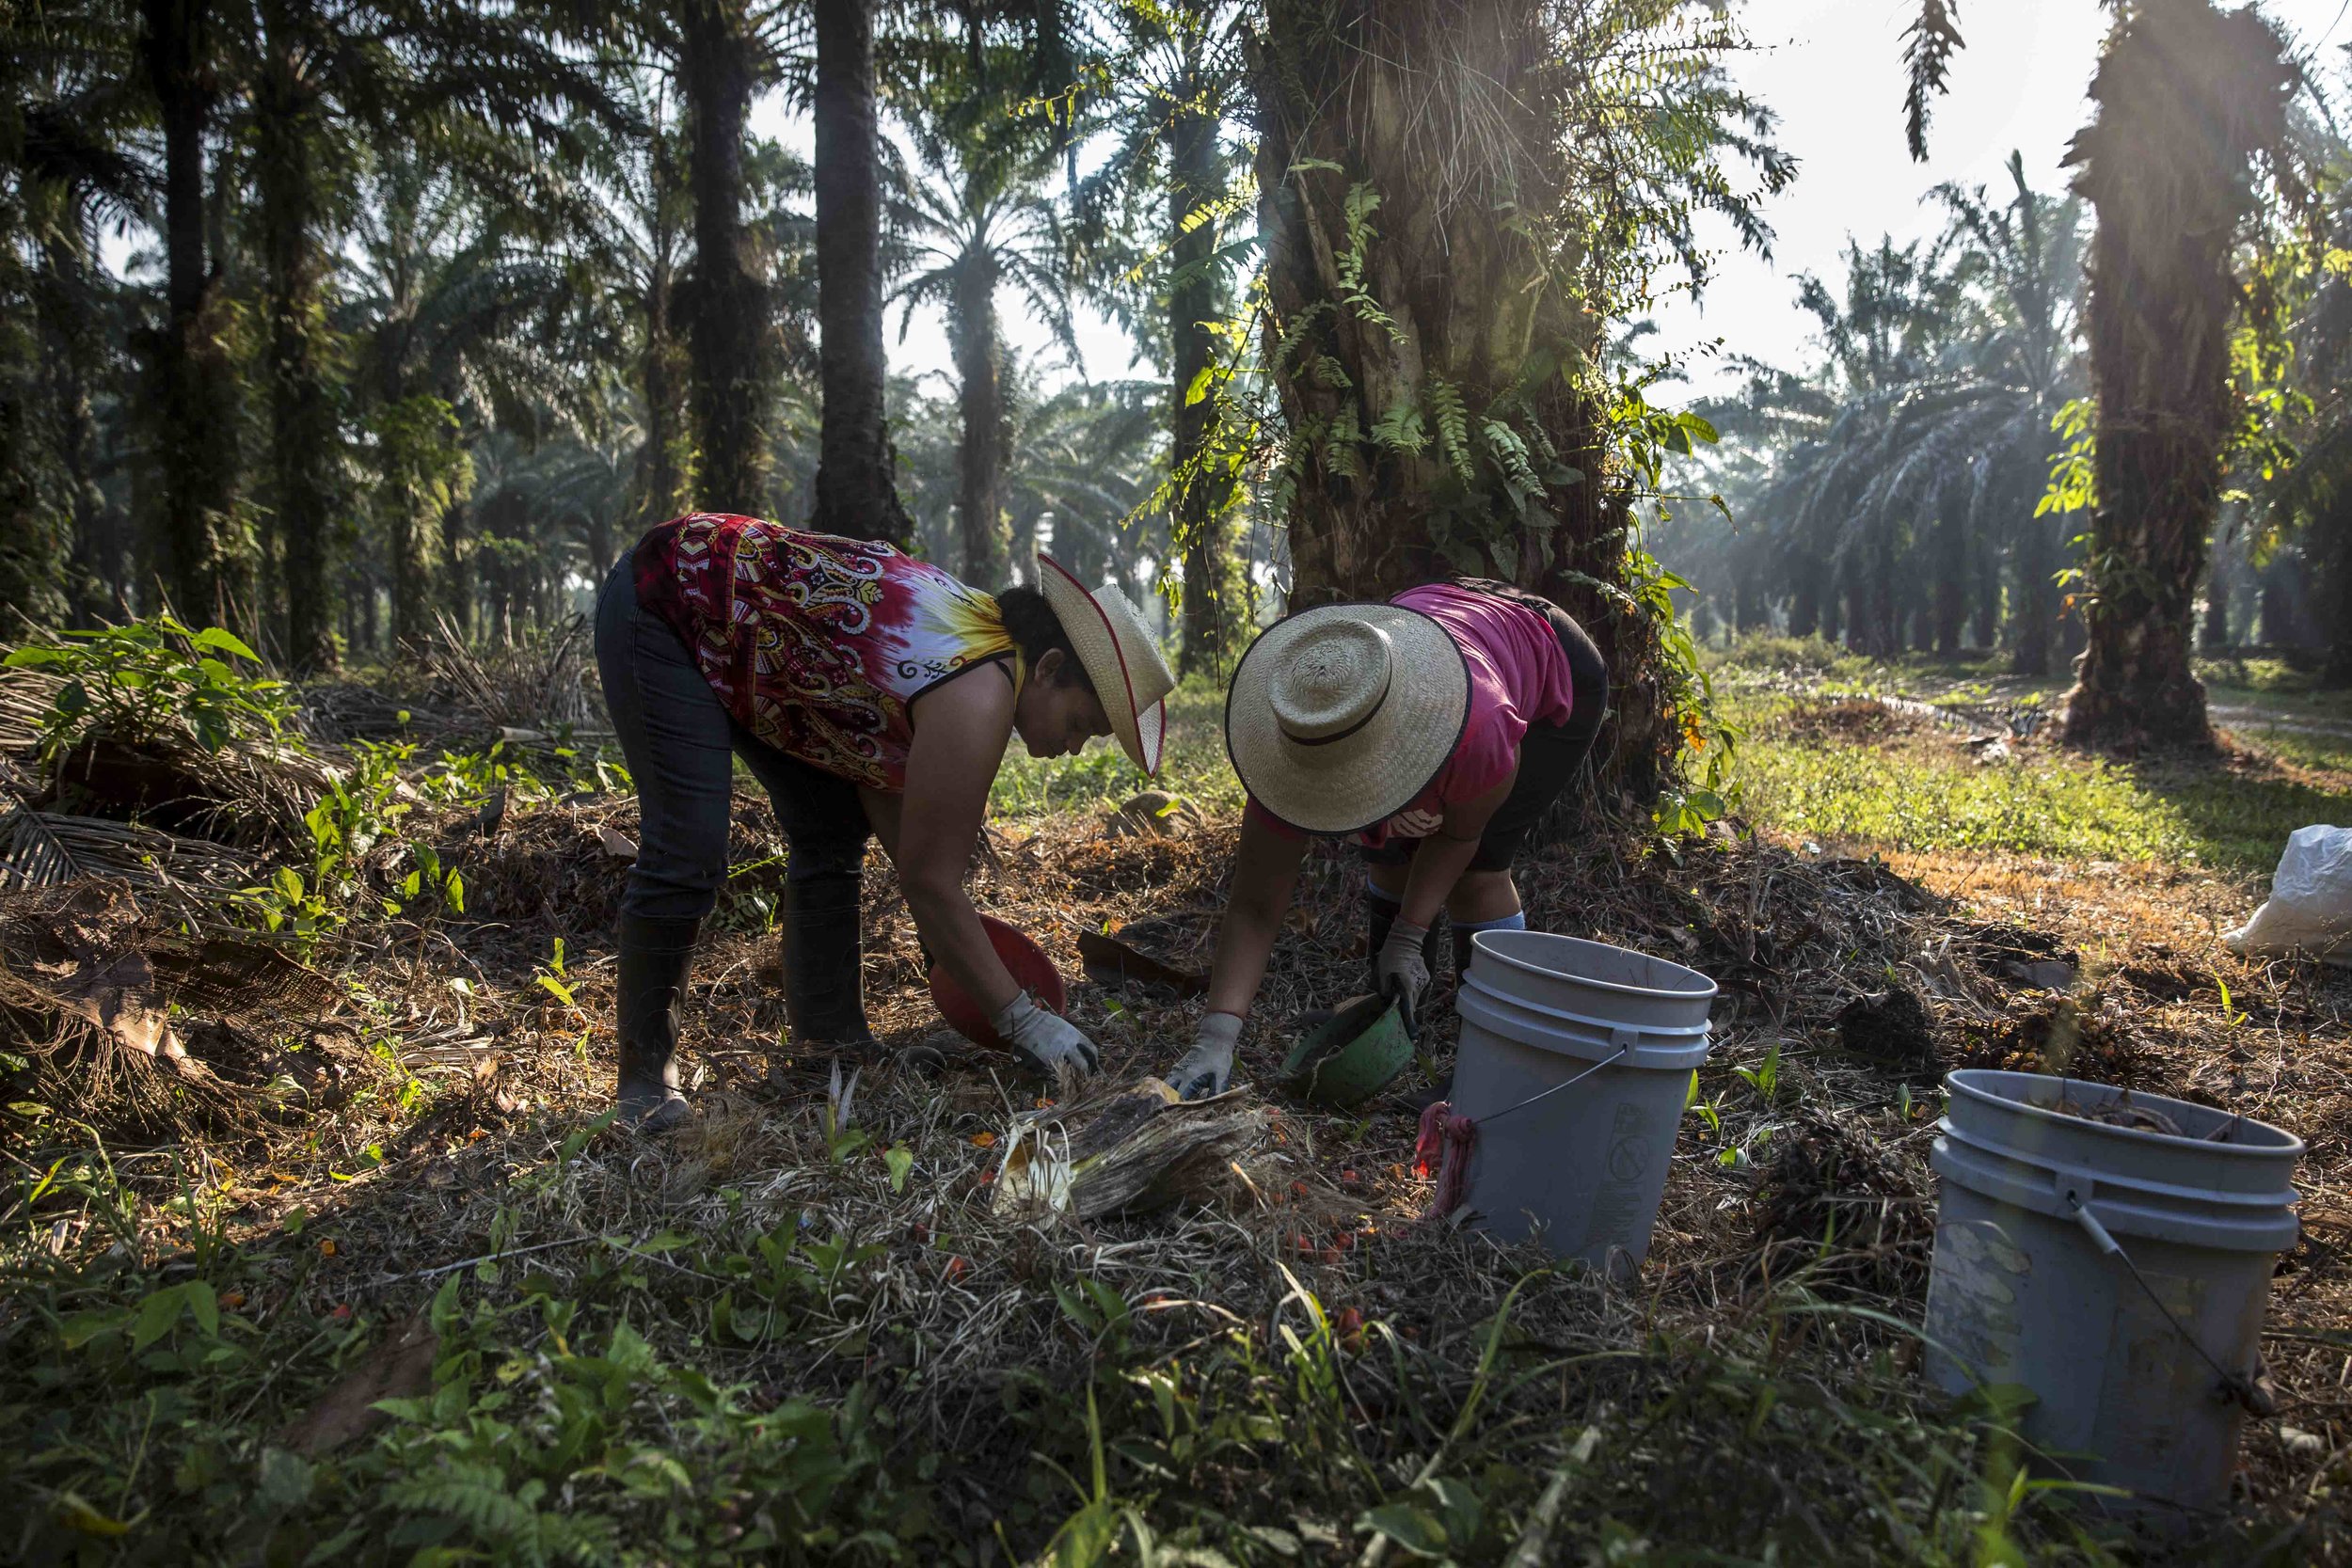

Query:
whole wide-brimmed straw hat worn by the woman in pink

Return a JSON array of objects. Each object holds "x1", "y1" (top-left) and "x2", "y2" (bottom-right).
[{"x1": 1226, "y1": 604, "x2": 1470, "y2": 832}]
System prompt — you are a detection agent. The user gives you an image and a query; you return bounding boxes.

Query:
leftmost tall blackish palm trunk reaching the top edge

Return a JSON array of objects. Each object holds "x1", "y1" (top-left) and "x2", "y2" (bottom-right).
[{"x1": 139, "y1": 0, "x2": 245, "y2": 618}]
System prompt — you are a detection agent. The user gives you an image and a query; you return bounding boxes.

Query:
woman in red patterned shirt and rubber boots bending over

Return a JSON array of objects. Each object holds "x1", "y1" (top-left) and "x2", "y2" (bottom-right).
[{"x1": 596, "y1": 513, "x2": 1176, "y2": 1131}]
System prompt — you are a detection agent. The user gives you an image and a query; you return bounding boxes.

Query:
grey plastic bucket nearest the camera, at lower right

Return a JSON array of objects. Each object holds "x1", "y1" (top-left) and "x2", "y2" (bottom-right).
[{"x1": 1927, "y1": 1068, "x2": 2303, "y2": 1510}]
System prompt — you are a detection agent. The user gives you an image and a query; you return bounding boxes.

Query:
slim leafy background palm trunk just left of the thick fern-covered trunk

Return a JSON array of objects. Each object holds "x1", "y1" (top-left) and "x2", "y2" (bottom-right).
[{"x1": 1169, "y1": 57, "x2": 1240, "y2": 674}]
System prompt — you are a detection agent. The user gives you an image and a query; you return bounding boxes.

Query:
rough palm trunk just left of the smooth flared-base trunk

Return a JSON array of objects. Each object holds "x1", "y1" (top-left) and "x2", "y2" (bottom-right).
[{"x1": 677, "y1": 0, "x2": 776, "y2": 513}]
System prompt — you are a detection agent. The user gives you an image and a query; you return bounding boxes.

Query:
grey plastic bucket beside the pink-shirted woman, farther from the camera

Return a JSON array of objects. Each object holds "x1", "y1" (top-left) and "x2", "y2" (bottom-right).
[{"x1": 1454, "y1": 931, "x2": 1715, "y2": 1272}]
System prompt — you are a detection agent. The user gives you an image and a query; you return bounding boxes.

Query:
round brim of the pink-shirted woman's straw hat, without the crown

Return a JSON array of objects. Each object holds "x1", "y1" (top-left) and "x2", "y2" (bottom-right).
[{"x1": 1226, "y1": 604, "x2": 1470, "y2": 834}]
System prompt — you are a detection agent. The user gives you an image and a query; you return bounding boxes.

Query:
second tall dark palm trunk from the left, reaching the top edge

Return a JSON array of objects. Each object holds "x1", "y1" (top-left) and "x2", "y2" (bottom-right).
[{"x1": 254, "y1": 0, "x2": 342, "y2": 673}]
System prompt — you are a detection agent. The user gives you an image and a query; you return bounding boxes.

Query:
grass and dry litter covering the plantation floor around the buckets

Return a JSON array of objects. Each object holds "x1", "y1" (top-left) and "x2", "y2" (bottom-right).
[{"x1": 13, "y1": 629, "x2": 2352, "y2": 1568}]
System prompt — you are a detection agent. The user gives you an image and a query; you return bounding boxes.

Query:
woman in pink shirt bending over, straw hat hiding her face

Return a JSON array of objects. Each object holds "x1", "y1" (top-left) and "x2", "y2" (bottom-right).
[{"x1": 1167, "y1": 578, "x2": 1609, "y2": 1101}]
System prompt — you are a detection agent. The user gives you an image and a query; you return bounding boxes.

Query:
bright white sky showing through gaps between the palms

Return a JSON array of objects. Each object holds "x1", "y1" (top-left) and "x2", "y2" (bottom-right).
[{"x1": 809, "y1": 0, "x2": 2352, "y2": 395}]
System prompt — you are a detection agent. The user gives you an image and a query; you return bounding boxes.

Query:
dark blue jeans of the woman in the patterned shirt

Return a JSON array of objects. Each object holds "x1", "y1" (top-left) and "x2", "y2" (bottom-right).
[{"x1": 596, "y1": 552, "x2": 870, "y2": 919}]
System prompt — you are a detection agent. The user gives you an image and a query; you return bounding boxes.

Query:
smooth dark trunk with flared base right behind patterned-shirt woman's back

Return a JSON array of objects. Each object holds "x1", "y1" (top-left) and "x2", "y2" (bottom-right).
[{"x1": 814, "y1": 0, "x2": 915, "y2": 547}]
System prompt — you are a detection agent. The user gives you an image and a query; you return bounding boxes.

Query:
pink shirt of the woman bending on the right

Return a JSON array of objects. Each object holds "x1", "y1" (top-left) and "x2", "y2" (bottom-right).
[{"x1": 1249, "y1": 583, "x2": 1576, "y2": 848}]
